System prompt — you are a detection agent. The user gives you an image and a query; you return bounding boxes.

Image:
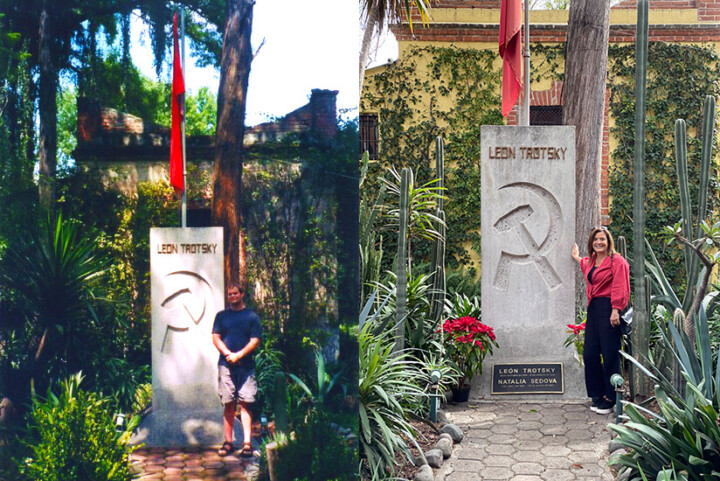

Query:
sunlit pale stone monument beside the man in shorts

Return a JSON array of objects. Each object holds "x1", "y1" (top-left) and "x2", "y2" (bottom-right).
[{"x1": 133, "y1": 227, "x2": 239, "y2": 447}]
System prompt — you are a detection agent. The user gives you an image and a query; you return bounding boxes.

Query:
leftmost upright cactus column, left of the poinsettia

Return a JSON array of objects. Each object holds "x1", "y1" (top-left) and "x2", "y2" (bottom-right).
[{"x1": 394, "y1": 167, "x2": 412, "y2": 352}]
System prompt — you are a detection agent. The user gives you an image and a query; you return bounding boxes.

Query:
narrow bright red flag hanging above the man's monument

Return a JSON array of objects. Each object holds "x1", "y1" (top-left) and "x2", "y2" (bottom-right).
[{"x1": 170, "y1": 13, "x2": 185, "y2": 192}]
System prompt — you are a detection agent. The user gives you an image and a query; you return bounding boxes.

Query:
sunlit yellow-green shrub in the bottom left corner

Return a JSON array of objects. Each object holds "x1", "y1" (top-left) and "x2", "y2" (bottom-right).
[{"x1": 19, "y1": 373, "x2": 137, "y2": 481}]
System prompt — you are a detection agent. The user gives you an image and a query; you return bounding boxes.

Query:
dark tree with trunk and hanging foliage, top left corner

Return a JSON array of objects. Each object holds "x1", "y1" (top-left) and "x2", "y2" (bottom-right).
[{"x1": 0, "y1": 0, "x2": 225, "y2": 211}]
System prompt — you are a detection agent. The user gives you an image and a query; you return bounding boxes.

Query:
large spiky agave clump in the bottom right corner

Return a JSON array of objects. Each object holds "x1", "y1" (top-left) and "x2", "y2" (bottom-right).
[{"x1": 610, "y1": 307, "x2": 720, "y2": 480}]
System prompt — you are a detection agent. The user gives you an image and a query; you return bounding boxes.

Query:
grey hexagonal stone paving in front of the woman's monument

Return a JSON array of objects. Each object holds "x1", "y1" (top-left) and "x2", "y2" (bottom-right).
[{"x1": 435, "y1": 401, "x2": 615, "y2": 481}]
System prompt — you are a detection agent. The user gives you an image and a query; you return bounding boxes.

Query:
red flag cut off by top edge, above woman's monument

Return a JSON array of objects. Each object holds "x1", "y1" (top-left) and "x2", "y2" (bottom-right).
[{"x1": 500, "y1": 0, "x2": 527, "y2": 117}]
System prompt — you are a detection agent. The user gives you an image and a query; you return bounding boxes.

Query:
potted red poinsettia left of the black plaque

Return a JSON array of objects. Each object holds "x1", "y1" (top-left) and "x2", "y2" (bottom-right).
[{"x1": 439, "y1": 316, "x2": 498, "y2": 402}]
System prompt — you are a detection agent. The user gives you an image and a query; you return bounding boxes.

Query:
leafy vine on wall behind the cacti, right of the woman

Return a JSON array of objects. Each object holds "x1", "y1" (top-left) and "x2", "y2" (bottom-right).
[{"x1": 608, "y1": 42, "x2": 720, "y2": 286}]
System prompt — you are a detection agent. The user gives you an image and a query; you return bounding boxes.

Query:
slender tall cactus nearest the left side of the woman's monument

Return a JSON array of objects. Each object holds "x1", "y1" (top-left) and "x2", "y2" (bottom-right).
[{"x1": 431, "y1": 136, "x2": 446, "y2": 325}]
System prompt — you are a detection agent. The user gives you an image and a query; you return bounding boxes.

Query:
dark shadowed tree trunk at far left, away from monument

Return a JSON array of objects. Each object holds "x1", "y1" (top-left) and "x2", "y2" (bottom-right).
[{"x1": 38, "y1": 0, "x2": 58, "y2": 216}]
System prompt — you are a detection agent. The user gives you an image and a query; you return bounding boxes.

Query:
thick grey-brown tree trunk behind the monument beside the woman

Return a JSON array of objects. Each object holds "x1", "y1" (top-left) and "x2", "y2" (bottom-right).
[{"x1": 563, "y1": 0, "x2": 610, "y2": 305}]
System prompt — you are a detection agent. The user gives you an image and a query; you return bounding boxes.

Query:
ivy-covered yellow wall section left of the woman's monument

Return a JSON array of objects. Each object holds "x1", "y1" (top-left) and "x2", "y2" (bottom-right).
[{"x1": 361, "y1": 46, "x2": 503, "y2": 267}]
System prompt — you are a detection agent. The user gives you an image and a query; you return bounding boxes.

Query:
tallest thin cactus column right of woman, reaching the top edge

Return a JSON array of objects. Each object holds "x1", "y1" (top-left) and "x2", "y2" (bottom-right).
[{"x1": 630, "y1": 0, "x2": 650, "y2": 396}]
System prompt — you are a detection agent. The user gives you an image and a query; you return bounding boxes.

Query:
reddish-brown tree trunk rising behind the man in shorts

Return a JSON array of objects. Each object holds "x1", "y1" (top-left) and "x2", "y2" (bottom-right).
[{"x1": 212, "y1": 0, "x2": 254, "y2": 285}]
